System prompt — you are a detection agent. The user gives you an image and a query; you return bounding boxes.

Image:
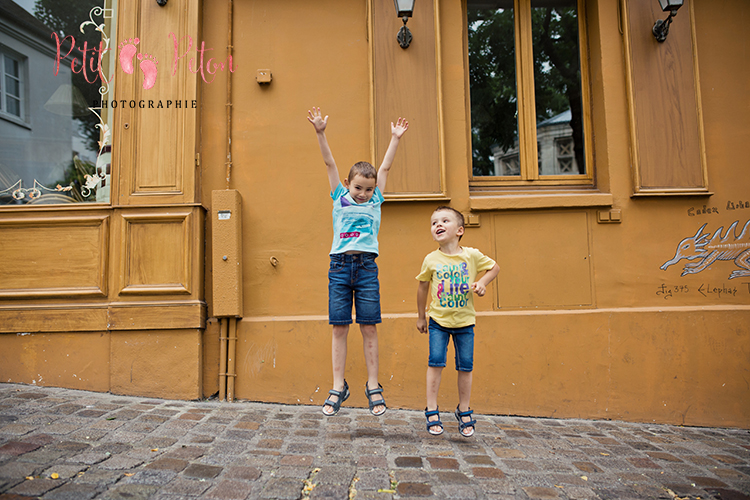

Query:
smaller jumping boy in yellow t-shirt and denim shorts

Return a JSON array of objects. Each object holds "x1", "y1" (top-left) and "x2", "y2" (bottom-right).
[{"x1": 417, "y1": 206, "x2": 500, "y2": 437}]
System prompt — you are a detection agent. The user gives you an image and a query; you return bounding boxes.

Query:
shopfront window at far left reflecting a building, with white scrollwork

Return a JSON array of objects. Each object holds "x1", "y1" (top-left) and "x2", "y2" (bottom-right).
[{"x1": 0, "y1": 0, "x2": 118, "y2": 206}]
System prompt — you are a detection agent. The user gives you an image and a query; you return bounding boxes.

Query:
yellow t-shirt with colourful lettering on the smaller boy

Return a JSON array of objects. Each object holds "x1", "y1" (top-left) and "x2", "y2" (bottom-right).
[{"x1": 417, "y1": 247, "x2": 495, "y2": 328}]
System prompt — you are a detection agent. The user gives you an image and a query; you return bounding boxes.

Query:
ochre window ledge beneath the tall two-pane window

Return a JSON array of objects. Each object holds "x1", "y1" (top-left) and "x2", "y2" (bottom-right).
[{"x1": 469, "y1": 192, "x2": 614, "y2": 211}]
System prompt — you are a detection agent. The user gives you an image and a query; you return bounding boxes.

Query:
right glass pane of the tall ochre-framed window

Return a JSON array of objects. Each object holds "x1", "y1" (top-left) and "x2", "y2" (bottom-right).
[{"x1": 531, "y1": 0, "x2": 586, "y2": 175}]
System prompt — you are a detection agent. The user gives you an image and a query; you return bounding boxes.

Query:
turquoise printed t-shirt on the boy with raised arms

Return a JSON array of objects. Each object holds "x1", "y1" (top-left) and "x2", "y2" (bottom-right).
[{"x1": 331, "y1": 183, "x2": 385, "y2": 254}]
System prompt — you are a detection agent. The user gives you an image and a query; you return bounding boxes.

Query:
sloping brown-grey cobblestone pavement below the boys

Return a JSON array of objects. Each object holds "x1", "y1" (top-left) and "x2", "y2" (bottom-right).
[{"x1": 0, "y1": 384, "x2": 750, "y2": 500}]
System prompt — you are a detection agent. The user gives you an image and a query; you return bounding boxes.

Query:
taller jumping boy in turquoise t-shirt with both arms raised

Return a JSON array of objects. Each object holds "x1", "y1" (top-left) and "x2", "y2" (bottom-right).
[{"x1": 307, "y1": 108, "x2": 409, "y2": 416}]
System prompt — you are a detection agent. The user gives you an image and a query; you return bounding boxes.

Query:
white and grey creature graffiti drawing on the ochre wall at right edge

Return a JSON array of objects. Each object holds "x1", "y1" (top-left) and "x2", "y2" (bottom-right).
[{"x1": 660, "y1": 220, "x2": 750, "y2": 280}]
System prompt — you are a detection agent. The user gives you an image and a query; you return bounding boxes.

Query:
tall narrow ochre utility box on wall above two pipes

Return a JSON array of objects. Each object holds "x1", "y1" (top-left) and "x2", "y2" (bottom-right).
[{"x1": 211, "y1": 189, "x2": 242, "y2": 318}]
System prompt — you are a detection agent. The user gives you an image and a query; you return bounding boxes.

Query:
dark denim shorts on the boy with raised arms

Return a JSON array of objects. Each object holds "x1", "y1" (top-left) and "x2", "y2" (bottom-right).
[{"x1": 328, "y1": 253, "x2": 381, "y2": 325}]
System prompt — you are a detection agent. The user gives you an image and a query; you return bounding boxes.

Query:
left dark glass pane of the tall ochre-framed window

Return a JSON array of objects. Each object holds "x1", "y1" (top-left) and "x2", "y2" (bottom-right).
[{"x1": 468, "y1": 0, "x2": 520, "y2": 176}]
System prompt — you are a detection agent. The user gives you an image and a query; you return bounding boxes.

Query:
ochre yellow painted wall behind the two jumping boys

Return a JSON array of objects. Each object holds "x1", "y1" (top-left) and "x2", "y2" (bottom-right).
[{"x1": 202, "y1": 0, "x2": 750, "y2": 427}]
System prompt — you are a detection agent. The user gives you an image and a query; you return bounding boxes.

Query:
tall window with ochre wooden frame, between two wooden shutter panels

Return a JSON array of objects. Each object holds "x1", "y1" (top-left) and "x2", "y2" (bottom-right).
[{"x1": 467, "y1": 0, "x2": 592, "y2": 185}]
